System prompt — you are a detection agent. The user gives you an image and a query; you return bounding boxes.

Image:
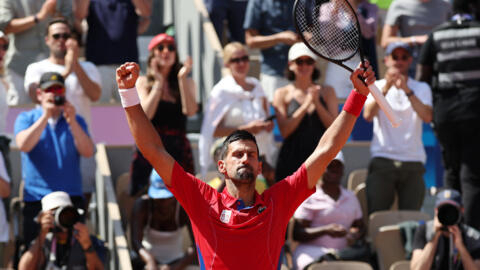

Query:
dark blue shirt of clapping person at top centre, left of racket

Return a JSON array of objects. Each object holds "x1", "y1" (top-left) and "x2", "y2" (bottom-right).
[{"x1": 243, "y1": 0, "x2": 296, "y2": 77}]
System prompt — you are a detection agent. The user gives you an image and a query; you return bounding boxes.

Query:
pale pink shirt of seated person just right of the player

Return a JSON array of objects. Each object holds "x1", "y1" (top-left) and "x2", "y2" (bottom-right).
[{"x1": 294, "y1": 187, "x2": 362, "y2": 249}]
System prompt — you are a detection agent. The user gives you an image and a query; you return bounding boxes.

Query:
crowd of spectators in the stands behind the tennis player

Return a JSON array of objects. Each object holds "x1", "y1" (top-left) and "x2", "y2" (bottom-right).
[{"x1": 0, "y1": 0, "x2": 480, "y2": 269}]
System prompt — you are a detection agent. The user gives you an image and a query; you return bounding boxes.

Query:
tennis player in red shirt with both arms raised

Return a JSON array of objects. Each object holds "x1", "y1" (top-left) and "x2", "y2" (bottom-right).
[{"x1": 117, "y1": 62, "x2": 375, "y2": 270}]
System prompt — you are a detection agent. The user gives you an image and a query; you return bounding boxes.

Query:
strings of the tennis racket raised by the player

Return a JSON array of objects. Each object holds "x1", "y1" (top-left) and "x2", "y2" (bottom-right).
[{"x1": 295, "y1": 0, "x2": 360, "y2": 61}]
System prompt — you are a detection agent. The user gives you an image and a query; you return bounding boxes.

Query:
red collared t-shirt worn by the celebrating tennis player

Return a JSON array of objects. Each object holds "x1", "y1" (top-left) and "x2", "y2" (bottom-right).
[{"x1": 169, "y1": 163, "x2": 315, "y2": 270}]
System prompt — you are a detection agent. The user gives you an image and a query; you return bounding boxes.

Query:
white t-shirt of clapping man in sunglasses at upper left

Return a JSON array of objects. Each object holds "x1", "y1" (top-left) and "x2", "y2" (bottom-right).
[{"x1": 24, "y1": 59, "x2": 101, "y2": 132}]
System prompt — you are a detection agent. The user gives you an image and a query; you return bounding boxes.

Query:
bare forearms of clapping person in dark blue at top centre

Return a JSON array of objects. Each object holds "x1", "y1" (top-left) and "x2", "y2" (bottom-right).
[{"x1": 245, "y1": 29, "x2": 299, "y2": 49}]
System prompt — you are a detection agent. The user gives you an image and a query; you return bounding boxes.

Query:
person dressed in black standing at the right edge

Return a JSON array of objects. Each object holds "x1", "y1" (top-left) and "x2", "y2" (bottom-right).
[{"x1": 417, "y1": 0, "x2": 480, "y2": 229}]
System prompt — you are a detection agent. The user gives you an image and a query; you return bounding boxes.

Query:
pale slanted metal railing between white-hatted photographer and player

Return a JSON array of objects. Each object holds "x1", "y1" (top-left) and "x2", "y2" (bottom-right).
[{"x1": 92, "y1": 144, "x2": 132, "y2": 270}]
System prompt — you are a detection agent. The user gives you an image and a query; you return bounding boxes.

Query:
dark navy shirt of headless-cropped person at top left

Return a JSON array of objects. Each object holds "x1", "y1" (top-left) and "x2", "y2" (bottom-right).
[{"x1": 85, "y1": 0, "x2": 139, "y2": 65}]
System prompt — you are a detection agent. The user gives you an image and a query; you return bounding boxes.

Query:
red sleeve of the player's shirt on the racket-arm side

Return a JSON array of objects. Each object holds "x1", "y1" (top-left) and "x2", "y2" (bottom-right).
[{"x1": 264, "y1": 164, "x2": 316, "y2": 219}]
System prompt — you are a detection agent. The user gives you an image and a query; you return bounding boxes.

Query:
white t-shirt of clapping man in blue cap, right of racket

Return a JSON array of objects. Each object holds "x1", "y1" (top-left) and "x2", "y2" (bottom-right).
[{"x1": 366, "y1": 78, "x2": 432, "y2": 163}]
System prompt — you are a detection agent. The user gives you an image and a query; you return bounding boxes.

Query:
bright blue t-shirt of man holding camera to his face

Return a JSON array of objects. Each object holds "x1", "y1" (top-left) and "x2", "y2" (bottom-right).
[{"x1": 14, "y1": 108, "x2": 88, "y2": 202}]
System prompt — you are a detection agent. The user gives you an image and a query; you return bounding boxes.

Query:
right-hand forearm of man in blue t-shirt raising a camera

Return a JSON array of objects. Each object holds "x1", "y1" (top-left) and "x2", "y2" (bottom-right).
[{"x1": 63, "y1": 101, "x2": 95, "y2": 157}]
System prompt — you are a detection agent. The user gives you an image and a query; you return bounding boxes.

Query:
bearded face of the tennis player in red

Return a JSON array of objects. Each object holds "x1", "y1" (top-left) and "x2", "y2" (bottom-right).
[{"x1": 218, "y1": 140, "x2": 262, "y2": 184}]
